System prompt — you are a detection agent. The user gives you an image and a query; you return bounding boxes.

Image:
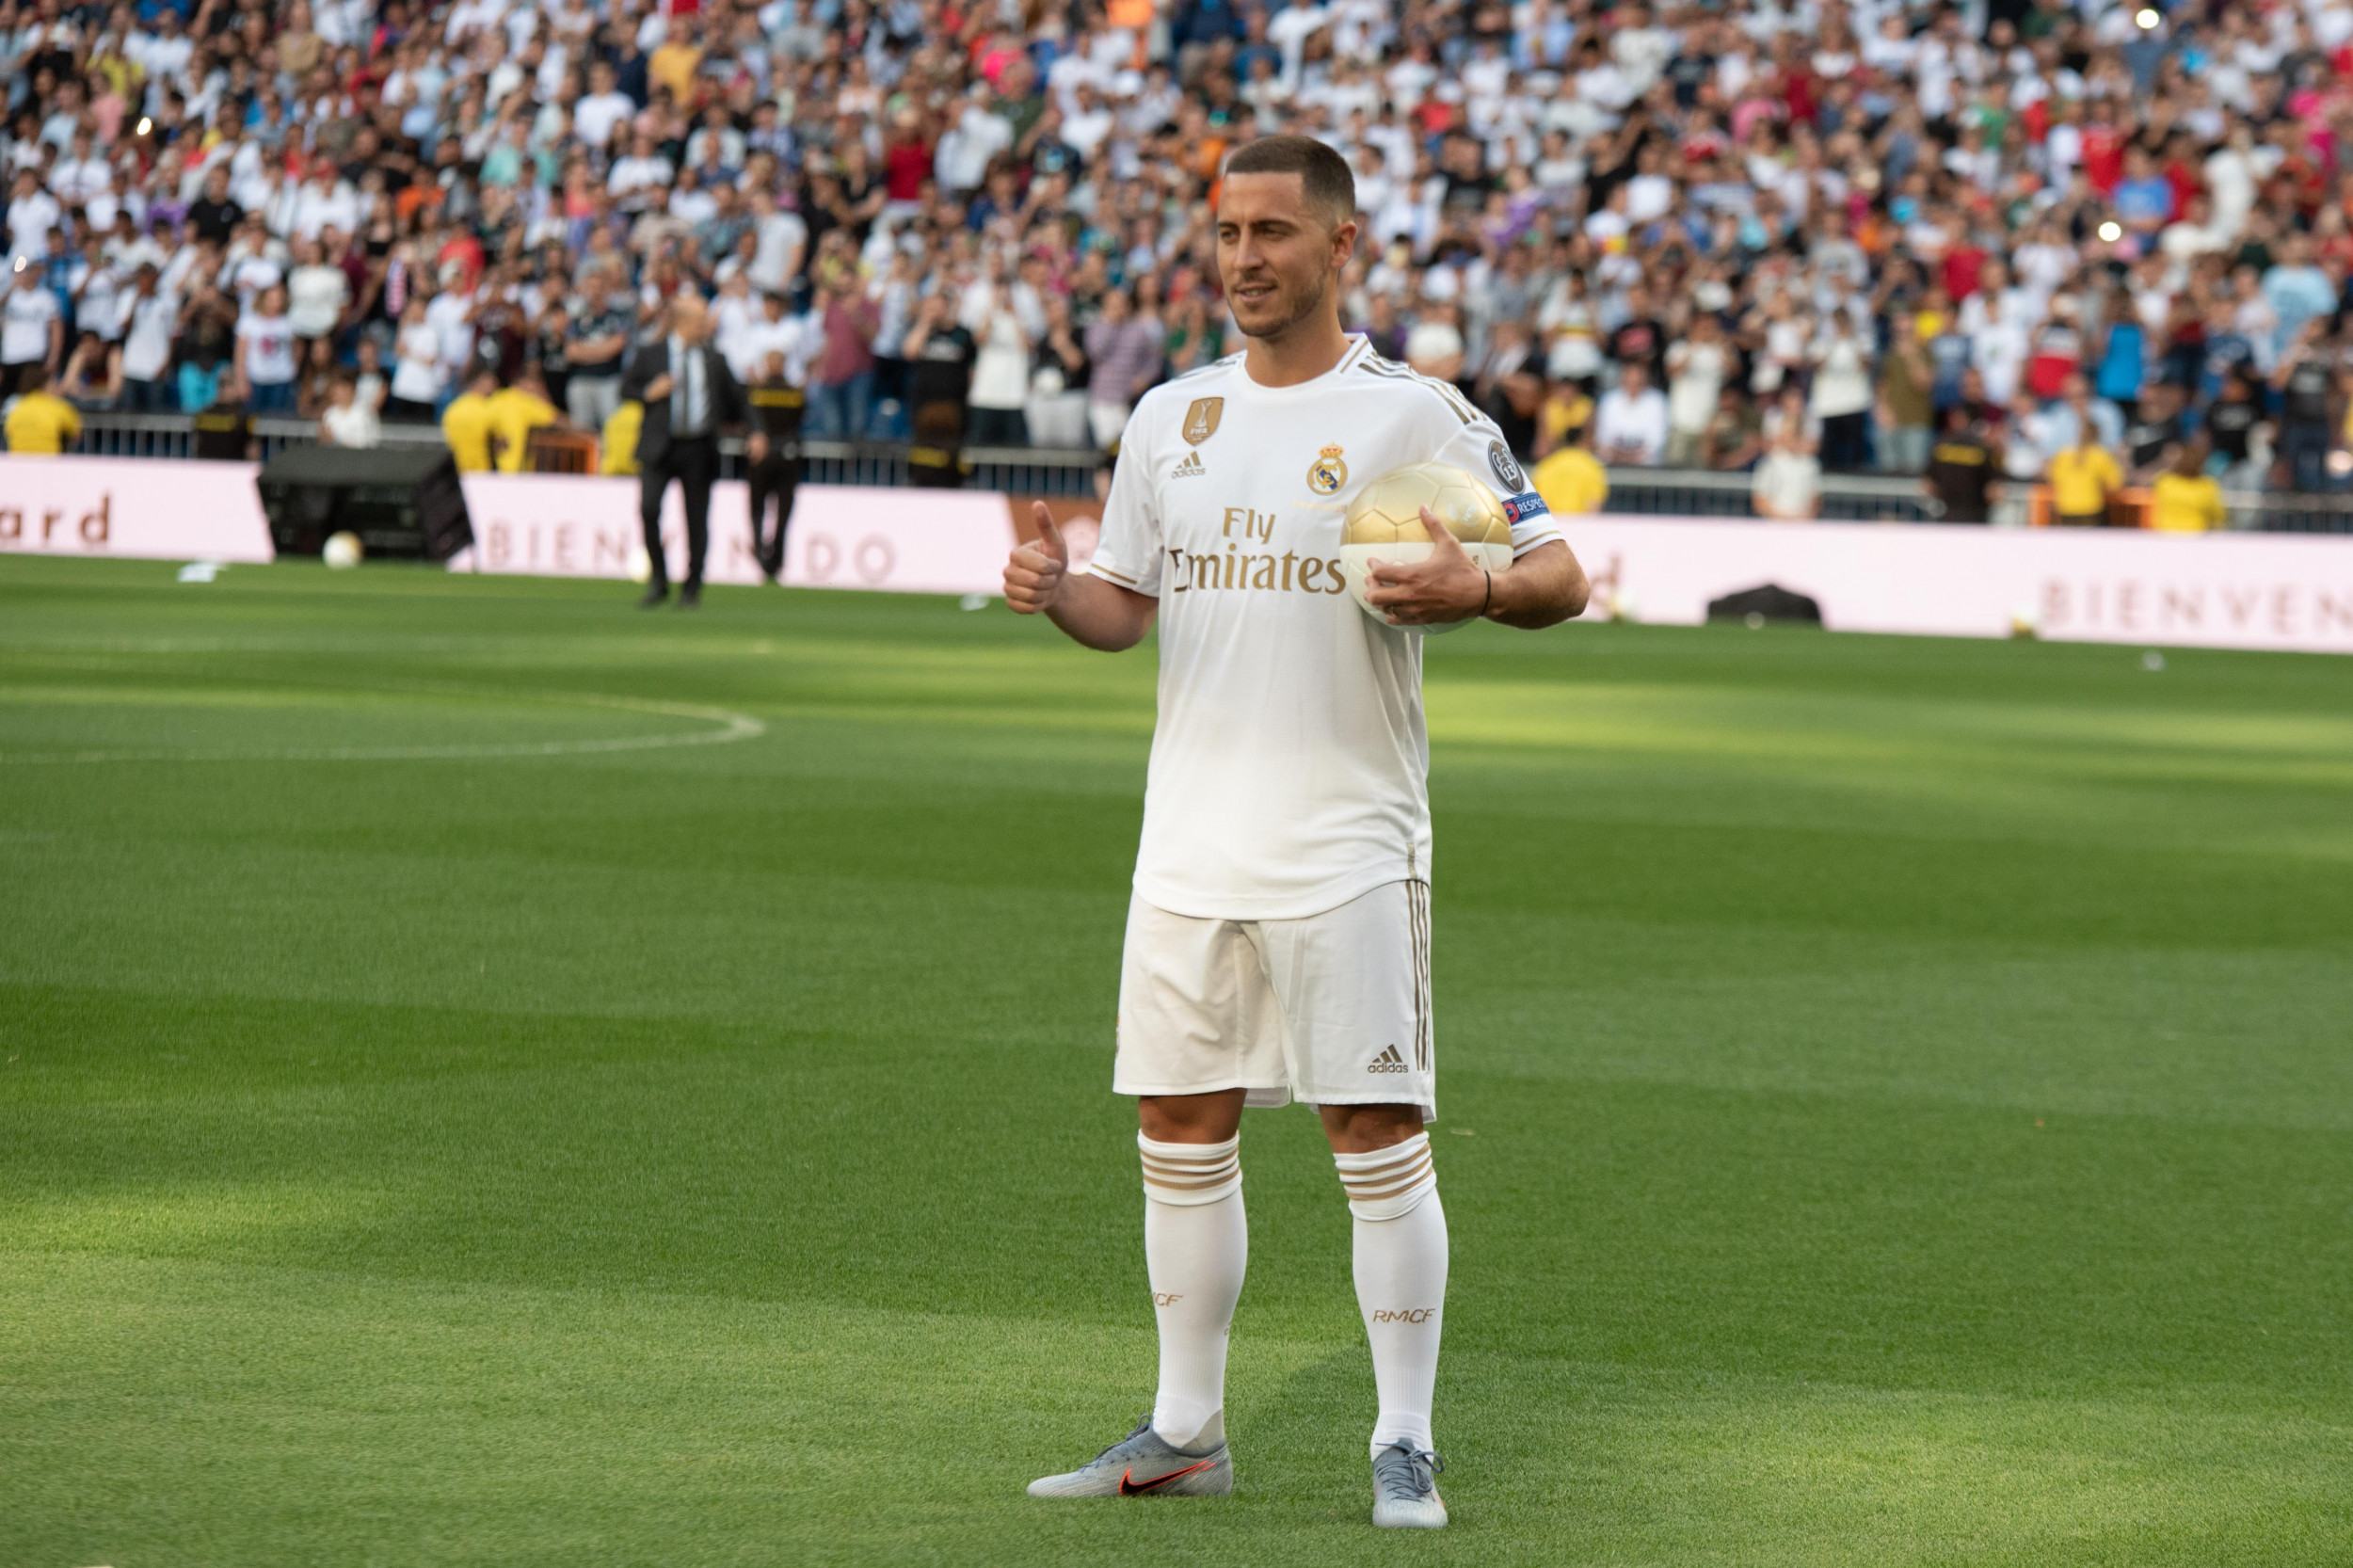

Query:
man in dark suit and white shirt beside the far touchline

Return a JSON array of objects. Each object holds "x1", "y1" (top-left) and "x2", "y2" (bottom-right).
[{"x1": 621, "y1": 295, "x2": 767, "y2": 610}]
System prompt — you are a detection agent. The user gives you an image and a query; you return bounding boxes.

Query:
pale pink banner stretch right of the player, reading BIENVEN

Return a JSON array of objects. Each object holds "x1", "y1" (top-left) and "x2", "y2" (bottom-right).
[{"x1": 1561, "y1": 516, "x2": 2353, "y2": 652}]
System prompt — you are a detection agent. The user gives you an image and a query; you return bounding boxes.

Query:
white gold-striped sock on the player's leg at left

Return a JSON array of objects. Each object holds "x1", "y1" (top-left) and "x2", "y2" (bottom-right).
[{"x1": 1137, "y1": 1135, "x2": 1250, "y2": 1450}]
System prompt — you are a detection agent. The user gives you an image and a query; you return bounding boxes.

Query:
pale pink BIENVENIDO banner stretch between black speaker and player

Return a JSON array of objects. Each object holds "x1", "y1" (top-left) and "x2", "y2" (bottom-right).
[{"x1": 450, "y1": 473, "x2": 1015, "y2": 593}]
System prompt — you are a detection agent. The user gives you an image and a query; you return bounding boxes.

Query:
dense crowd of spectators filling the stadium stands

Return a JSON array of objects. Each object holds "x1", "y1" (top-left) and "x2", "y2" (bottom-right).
[{"x1": 0, "y1": 0, "x2": 2353, "y2": 513}]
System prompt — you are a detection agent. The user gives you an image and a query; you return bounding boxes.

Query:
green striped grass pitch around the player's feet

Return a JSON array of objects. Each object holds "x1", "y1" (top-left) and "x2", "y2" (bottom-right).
[{"x1": 0, "y1": 558, "x2": 2353, "y2": 1568}]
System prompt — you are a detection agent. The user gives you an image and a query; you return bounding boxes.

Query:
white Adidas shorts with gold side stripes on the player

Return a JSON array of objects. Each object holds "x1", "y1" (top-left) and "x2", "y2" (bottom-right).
[{"x1": 1111, "y1": 883, "x2": 1438, "y2": 1121}]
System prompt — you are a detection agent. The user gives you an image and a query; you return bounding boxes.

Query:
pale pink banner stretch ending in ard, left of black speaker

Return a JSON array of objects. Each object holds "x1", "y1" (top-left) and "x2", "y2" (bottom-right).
[{"x1": 0, "y1": 456, "x2": 276, "y2": 563}]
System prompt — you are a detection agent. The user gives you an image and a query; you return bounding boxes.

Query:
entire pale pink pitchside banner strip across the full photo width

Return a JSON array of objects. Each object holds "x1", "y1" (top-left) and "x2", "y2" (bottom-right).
[{"x1": 0, "y1": 456, "x2": 2353, "y2": 652}]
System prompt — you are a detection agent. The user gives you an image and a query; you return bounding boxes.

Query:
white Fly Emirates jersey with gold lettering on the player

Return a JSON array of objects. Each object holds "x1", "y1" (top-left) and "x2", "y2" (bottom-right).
[{"x1": 1087, "y1": 337, "x2": 1561, "y2": 920}]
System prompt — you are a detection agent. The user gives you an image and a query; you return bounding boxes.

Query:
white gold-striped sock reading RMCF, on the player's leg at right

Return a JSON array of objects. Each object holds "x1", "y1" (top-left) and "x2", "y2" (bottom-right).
[{"x1": 1332, "y1": 1132, "x2": 1448, "y2": 1452}]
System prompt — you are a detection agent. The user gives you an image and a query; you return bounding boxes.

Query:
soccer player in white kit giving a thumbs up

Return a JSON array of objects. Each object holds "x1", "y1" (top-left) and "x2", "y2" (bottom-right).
[{"x1": 1005, "y1": 136, "x2": 1586, "y2": 1528}]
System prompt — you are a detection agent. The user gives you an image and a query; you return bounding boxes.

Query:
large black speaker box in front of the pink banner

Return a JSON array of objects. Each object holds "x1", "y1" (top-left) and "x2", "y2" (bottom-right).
[{"x1": 262, "y1": 447, "x2": 473, "y2": 560}]
